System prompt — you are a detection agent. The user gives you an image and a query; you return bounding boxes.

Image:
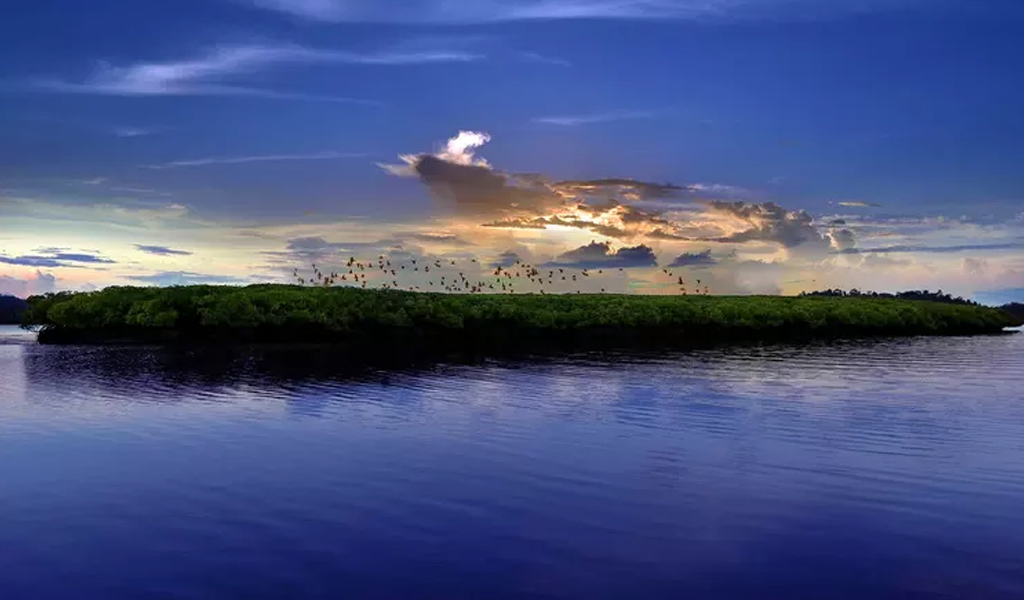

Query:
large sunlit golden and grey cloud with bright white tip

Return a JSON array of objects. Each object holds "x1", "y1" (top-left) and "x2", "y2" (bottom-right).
[{"x1": 380, "y1": 131, "x2": 856, "y2": 257}]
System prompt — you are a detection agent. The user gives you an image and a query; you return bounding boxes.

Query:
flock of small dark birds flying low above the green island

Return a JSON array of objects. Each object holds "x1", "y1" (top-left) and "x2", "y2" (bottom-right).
[{"x1": 293, "y1": 255, "x2": 711, "y2": 296}]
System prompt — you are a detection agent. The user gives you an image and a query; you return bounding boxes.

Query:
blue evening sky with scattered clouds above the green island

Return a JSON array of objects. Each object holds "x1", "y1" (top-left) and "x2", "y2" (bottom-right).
[{"x1": 0, "y1": 0, "x2": 1024, "y2": 303}]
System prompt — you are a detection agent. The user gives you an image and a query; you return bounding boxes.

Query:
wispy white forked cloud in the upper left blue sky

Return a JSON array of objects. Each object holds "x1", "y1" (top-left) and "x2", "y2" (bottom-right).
[{"x1": 35, "y1": 45, "x2": 483, "y2": 100}]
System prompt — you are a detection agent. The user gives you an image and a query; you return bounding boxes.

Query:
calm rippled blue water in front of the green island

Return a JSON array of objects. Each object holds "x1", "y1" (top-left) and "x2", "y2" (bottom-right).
[{"x1": 0, "y1": 330, "x2": 1024, "y2": 600}]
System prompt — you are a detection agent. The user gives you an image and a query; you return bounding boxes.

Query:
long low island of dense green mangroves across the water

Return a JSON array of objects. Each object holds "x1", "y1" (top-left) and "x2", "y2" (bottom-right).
[{"x1": 19, "y1": 285, "x2": 1020, "y2": 351}]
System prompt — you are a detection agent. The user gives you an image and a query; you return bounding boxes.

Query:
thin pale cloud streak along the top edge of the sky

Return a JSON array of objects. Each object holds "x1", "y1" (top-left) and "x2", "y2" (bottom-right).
[{"x1": 231, "y1": 0, "x2": 927, "y2": 25}]
